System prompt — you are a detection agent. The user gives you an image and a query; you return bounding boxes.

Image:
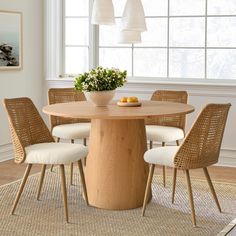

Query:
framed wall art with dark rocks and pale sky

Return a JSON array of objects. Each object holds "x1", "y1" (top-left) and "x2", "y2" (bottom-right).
[{"x1": 0, "y1": 10, "x2": 22, "y2": 70}]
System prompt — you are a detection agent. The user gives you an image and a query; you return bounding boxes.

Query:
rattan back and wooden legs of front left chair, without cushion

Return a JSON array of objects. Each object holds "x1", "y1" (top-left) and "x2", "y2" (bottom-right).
[{"x1": 3, "y1": 97, "x2": 88, "y2": 222}]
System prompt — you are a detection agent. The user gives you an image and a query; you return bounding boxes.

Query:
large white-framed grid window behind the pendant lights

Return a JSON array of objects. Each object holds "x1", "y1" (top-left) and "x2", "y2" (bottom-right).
[{"x1": 53, "y1": 0, "x2": 236, "y2": 82}]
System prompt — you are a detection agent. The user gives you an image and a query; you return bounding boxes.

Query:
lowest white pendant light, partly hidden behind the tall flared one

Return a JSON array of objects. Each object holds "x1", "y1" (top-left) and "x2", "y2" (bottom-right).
[{"x1": 118, "y1": 30, "x2": 142, "y2": 43}]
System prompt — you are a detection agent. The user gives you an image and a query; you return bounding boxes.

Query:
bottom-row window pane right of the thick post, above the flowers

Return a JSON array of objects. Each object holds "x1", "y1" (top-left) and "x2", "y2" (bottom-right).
[{"x1": 99, "y1": 48, "x2": 132, "y2": 75}]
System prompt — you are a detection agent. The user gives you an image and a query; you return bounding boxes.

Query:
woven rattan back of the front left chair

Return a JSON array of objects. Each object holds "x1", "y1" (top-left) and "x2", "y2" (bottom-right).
[{"x1": 3, "y1": 98, "x2": 54, "y2": 163}]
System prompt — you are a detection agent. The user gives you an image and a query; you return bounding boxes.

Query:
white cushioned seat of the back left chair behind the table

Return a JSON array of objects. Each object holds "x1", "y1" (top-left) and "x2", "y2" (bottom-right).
[{"x1": 52, "y1": 123, "x2": 91, "y2": 139}]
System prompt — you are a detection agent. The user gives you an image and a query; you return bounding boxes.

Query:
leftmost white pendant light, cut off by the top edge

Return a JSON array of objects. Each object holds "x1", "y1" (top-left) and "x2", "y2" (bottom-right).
[{"x1": 91, "y1": 0, "x2": 115, "y2": 25}]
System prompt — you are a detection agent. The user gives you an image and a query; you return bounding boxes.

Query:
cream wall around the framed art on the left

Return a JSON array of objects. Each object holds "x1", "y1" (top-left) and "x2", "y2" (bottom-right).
[{"x1": 0, "y1": 0, "x2": 44, "y2": 161}]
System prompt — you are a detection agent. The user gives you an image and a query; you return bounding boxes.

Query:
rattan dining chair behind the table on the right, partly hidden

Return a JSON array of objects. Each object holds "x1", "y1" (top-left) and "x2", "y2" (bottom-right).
[{"x1": 146, "y1": 90, "x2": 188, "y2": 186}]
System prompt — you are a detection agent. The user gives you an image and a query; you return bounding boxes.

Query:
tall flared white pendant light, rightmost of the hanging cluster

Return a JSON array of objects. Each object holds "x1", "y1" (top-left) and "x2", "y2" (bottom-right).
[{"x1": 121, "y1": 0, "x2": 147, "y2": 32}]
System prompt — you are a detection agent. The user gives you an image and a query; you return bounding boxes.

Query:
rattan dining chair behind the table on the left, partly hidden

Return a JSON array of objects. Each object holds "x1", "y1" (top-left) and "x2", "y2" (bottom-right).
[{"x1": 48, "y1": 88, "x2": 91, "y2": 184}]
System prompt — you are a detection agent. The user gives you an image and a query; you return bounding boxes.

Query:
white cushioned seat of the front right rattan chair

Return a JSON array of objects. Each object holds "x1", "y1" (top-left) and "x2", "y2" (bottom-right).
[{"x1": 144, "y1": 146, "x2": 179, "y2": 167}]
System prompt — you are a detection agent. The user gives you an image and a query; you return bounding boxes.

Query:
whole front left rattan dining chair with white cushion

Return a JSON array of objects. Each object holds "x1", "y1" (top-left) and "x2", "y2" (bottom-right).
[{"x1": 3, "y1": 98, "x2": 88, "y2": 222}]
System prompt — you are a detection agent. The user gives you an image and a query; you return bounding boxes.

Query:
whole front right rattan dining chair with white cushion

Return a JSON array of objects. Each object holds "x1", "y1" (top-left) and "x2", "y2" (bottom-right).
[{"x1": 142, "y1": 104, "x2": 231, "y2": 226}]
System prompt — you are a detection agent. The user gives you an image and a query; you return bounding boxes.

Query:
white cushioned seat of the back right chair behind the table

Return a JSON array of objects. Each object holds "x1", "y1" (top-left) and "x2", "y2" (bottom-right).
[{"x1": 146, "y1": 125, "x2": 184, "y2": 142}]
